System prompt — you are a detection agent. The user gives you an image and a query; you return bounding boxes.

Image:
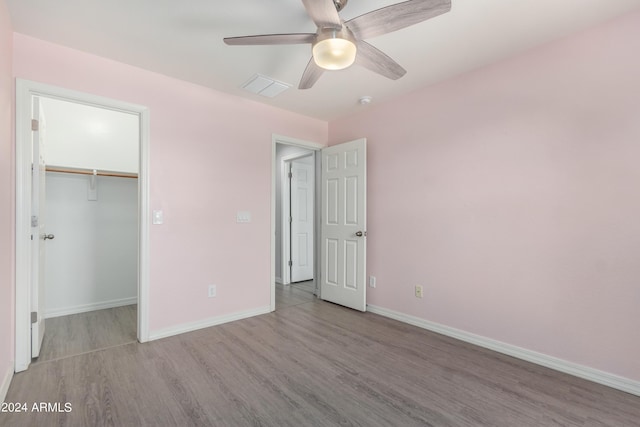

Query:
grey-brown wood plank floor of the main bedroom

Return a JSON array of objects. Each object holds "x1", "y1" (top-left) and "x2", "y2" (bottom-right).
[{"x1": 0, "y1": 299, "x2": 640, "y2": 427}]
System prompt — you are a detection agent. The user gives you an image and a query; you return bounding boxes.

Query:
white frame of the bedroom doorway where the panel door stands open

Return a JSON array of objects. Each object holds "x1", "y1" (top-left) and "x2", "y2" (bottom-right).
[{"x1": 270, "y1": 134, "x2": 327, "y2": 311}]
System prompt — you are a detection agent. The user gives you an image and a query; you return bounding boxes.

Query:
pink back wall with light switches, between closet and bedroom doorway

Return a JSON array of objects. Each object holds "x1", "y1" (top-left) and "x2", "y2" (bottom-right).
[{"x1": 14, "y1": 34, "x2": 328, "y2": 333}]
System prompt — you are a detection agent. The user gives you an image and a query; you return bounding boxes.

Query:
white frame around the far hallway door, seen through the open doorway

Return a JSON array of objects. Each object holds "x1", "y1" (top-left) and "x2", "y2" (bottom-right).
[{"x1": 280, "y1": 150, "x2": 317, "y2": 285}]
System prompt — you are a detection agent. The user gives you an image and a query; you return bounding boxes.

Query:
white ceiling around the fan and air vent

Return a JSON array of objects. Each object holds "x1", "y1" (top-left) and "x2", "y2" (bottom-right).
[{"x1": 6, "y1": 0, "x2": 640, "y2": 120}]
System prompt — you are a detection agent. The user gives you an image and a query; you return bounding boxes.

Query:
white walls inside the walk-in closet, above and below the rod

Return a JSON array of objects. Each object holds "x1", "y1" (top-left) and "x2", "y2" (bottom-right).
[{"x1": 40, "y1": 97, "x2": 140, "y2": 317}]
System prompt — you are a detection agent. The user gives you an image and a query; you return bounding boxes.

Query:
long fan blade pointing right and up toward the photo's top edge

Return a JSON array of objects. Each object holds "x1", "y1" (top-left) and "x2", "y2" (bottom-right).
[{"x1": 346, "y1": 0, "x2": 451, "y2": 39}]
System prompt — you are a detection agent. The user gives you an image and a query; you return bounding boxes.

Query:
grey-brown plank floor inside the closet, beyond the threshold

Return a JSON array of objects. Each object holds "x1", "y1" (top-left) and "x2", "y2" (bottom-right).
[{"x1": 34, "y1": 305, "x2": 137, "y2": 363}]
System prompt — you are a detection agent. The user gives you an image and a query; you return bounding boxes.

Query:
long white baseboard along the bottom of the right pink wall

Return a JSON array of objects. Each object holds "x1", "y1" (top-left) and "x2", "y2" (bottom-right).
[{"x1": 367, "y1": 305, "x2": 640, "y2": 396}]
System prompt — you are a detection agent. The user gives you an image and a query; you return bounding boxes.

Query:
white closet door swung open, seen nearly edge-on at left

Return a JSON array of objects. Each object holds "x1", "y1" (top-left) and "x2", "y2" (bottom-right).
[{"x1": 31, "y1": 97, "x2": 48, "y2": 357}]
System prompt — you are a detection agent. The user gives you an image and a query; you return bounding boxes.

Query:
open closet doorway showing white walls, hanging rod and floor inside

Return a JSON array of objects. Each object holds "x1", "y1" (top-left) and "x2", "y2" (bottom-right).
[{"x1": 34, "y1": 97, "x2": 140, "y2": 362}]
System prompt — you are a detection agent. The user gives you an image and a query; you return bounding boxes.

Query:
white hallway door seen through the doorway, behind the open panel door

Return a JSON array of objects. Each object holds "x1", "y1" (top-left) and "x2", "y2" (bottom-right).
[{"x1": 290, "y1": 156, "x2": 315, "y2": 282}]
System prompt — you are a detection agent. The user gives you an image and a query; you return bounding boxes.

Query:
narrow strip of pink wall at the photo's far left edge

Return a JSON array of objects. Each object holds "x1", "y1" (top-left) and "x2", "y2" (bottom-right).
[{"x1": 0, "y1": 1, "x2": 14, "y2": 386}]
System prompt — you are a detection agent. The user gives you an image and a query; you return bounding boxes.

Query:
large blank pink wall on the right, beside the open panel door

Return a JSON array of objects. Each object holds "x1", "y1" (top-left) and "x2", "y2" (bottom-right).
[{"x1": 329, "y1": 13, "x2": 640, "y2": 380}]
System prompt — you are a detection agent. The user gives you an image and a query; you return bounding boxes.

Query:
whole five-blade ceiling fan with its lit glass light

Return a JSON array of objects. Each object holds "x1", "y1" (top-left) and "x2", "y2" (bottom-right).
[{"x1": 224, "y1": 0, "x2": 451, "y2": 89}]
